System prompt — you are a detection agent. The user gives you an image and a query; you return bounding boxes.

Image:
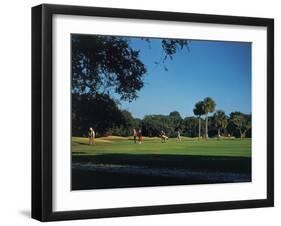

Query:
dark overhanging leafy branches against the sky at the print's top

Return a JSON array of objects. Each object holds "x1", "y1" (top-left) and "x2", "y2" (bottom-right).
[{"x1": 71, "y1": 34, "x2": 188, "y2": 101}]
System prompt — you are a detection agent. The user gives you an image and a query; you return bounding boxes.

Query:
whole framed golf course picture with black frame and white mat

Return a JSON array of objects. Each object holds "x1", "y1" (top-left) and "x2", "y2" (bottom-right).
[{"x1": 32, "y1": 4, "x2": 274, "y2": 221}]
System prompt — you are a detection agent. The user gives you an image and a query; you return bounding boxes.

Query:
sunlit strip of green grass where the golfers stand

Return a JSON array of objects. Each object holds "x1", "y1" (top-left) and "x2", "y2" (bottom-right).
[{"x1": 72, "y1": 137, "x2": 251, "y2": 157}]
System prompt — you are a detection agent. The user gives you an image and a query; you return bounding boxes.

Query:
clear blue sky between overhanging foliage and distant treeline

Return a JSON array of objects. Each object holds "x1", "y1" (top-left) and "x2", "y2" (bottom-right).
[{"x1": 117, "y1": 38, "x2": 251, "y2": 118}]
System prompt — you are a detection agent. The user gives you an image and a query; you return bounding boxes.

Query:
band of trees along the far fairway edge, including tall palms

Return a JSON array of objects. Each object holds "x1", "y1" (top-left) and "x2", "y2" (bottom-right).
[{"x1": 72, "y1": 94, "x2": 251, "y2": 138}]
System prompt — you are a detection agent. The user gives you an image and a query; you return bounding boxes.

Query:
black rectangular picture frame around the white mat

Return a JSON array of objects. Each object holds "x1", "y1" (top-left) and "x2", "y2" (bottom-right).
[{"x1": 32, "y1": 4, "x2": 274, "y2": 221}]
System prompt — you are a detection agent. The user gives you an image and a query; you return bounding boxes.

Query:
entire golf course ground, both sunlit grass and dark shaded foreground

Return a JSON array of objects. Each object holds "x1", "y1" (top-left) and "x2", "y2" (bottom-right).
[{"x1": 72, "y1": 136, "x2": 251, "y2": 190}]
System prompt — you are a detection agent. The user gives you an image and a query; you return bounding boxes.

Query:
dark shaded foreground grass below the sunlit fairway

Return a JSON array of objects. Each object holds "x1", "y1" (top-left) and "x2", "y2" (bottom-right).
[{"x1": 72, "y1": 154, "x2": 251, "y2": 190}]
